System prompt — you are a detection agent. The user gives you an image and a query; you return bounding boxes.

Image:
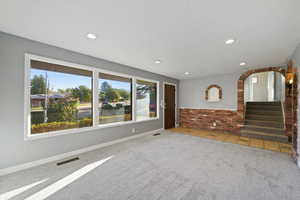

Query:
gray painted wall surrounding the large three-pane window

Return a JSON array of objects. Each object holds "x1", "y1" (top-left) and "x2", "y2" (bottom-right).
[{"x1": 0, "y1": 32, "x2": 178, "y2": 169}]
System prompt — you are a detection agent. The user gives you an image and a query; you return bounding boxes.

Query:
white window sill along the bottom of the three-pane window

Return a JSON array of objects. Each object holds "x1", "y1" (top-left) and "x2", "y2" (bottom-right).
[{"x1": 24, "y1": 117, "x2": 159, "y2": 140}]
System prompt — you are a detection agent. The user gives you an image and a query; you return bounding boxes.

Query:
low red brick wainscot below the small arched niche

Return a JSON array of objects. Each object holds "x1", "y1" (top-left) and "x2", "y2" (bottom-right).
[{"x1": 180, "y1": 108, "x2": 241, "y2": 133}]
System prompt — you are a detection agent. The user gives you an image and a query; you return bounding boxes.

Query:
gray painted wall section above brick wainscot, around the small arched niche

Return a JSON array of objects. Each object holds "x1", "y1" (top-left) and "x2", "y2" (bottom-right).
[{"x1": 179, "y1": 72, "x2": 242, "y2": 110}]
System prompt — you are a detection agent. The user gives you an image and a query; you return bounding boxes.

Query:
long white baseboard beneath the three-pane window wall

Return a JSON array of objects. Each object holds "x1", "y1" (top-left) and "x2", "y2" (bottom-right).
[{"x1": 0, "y1": 129, "x2": 163, "y2": 176}]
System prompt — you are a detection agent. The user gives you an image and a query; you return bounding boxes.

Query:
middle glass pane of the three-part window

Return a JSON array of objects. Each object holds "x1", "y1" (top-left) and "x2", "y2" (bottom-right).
[{"x1": 99, "y1": 73, "x2": 132, "y2": 124}]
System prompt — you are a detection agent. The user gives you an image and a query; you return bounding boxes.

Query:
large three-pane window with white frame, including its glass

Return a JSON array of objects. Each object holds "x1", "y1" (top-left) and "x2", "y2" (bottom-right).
[{"x1": 25, "y1": 54, "x2": 159, "y2": 139}]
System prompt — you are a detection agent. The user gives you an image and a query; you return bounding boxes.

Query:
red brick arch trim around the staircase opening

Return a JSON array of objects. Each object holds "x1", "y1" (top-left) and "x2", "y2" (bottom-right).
[{"x1": 237, "y1": 67, "x2": 286, "y2": 122}]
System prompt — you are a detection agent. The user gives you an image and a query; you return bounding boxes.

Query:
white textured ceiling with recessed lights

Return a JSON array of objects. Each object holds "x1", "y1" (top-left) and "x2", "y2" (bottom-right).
[{"x1": 0, "y1": 0, "x2": 300, "y2": 79}]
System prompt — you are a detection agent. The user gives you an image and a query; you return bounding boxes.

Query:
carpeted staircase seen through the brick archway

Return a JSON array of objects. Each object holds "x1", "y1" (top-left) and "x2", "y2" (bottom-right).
[{"x1": 241, "y1": 102, "x2": 289, "y2": 143}]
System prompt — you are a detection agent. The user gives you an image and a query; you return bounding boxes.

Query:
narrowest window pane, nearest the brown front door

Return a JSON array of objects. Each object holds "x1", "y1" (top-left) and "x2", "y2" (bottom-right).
[{"x1": 136, "y1": 80, "x2": 157, "y2": 120}]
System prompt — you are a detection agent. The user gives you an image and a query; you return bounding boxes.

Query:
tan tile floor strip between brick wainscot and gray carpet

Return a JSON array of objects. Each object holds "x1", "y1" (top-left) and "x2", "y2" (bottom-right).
[{"x1": 169, "y1": 127, "x2": 291, "y2": 154}]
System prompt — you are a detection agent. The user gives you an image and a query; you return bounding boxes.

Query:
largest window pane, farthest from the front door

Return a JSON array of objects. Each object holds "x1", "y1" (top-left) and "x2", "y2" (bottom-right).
[{"x1": 30, "y1": 60, "x2": 92, "y2": 134}]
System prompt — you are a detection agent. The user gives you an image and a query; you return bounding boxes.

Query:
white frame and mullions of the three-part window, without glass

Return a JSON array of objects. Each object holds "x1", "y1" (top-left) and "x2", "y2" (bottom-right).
[{"x1": 24, "y1": 53, "x2": 160, "y2": 140}]
